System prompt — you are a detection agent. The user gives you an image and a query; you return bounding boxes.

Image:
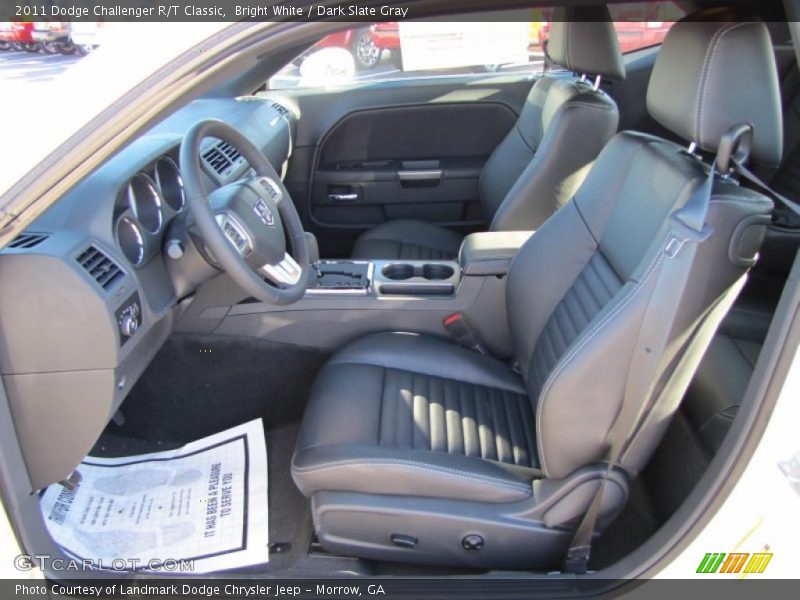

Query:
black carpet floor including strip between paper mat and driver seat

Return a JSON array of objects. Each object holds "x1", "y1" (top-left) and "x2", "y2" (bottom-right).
[{"x1": 90, "y1": 335, "x2": 327, "y2": 575}]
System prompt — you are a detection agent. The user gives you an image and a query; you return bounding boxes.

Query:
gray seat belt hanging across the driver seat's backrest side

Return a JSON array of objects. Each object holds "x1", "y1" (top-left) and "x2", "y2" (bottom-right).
[{"x1": 562, "y1": 125, "x2": 800, "y2": 574}]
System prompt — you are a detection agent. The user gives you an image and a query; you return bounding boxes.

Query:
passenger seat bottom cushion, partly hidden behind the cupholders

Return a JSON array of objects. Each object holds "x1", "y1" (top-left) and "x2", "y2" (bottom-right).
[{"x1": 352, "y1": 219, "x2": 464, "y2": 260}]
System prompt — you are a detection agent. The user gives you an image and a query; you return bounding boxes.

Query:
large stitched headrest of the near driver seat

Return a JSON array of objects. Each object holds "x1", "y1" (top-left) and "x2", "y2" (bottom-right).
[{"x1": 647, "y1": 11, "x2": 783, "y2": 166}]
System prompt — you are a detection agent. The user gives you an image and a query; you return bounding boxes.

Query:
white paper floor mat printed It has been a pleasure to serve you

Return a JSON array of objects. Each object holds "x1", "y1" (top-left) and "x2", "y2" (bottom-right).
[{"x1": 41, "y1": 419, "x2": 269, "y2": 573}]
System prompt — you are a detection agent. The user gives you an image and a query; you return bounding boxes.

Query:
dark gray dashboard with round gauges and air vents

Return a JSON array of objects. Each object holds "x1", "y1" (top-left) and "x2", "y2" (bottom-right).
[{"x1": 0, "y1": 96, "x2": 294, "y2": 489}]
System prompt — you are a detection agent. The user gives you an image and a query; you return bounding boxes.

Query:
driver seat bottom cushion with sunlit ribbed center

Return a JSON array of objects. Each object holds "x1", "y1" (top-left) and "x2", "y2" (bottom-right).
[{"x1": 292, "y1": 333, "x2": 540, "y2": 502}]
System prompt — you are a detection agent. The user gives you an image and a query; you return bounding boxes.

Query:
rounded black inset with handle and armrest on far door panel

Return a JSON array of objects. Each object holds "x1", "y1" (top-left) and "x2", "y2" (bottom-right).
[{"x1": 311, "y1": 102, "x2": 516, "y2": 225}]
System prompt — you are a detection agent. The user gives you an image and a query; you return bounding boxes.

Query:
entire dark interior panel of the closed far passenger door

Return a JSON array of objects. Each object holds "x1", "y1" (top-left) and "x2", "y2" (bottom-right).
[{"x1": 276, "y1": 76, "x2": 533, "y2": 257}]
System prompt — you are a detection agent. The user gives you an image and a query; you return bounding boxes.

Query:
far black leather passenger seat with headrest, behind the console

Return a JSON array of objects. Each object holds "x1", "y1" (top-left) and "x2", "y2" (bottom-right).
[{"x1": 352, "y1": 6, "x2": 625, "y2": 260}]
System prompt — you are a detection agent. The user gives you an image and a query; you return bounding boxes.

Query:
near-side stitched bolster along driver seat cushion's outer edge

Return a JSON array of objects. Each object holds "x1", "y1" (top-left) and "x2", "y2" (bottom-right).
[{"x1": 292, "y1": 444, "x2": 541, "y2": 502}]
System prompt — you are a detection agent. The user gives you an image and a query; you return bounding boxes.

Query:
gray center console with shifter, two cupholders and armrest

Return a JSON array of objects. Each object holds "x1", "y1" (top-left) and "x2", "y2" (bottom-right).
[{"x1": 178, "y1": 232, "x2": 531, "y2": 357}]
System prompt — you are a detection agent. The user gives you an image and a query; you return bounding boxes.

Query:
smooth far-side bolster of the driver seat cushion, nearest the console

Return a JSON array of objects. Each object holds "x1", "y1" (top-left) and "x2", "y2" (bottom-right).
[{"x1": 328, "y1": 332, "x2": 528, "y2": 395}]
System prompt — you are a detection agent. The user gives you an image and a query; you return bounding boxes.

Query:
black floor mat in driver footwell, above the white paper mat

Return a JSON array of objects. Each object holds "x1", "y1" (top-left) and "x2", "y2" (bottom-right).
[{"x1": 109, "y1": 335, "x2": 328, "y2": 444}]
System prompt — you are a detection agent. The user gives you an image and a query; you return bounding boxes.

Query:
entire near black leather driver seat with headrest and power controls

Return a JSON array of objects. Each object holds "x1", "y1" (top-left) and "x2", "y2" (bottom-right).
[{"x1": 292, "y1": 12, "x2": 782, "y2": 569}]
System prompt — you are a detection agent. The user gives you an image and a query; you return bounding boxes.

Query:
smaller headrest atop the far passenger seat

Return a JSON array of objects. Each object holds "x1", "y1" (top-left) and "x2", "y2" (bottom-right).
[{"x1": 547, "y1": 5, "x2": 625, "y2": 79}]
